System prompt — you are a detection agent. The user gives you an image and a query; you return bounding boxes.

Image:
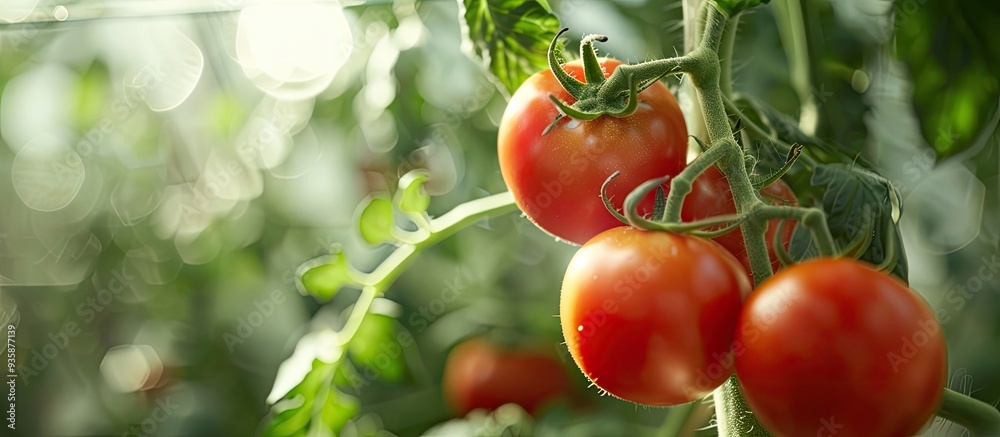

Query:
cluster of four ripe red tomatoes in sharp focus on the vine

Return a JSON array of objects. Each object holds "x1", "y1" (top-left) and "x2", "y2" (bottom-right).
[{"x1": 488, "y1": 60, "x2": 947, "y2": 436}]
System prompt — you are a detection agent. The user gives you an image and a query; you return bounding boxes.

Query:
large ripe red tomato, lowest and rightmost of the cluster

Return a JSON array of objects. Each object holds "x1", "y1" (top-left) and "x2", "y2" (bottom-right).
[{"x1": 734, "y1": 259, "x2": 947, "y2": 436}]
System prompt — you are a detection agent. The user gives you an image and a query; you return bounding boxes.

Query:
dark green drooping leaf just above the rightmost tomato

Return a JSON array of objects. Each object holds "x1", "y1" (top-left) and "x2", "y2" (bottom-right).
[{"x1": 789, "y1": 164, "x2": 908, "y2": 281}]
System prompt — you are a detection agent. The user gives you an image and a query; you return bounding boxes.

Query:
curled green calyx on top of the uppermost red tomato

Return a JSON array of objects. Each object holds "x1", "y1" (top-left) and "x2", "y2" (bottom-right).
[{"x1": 545, "y1": 28, "x2": 670, "y2": 127}]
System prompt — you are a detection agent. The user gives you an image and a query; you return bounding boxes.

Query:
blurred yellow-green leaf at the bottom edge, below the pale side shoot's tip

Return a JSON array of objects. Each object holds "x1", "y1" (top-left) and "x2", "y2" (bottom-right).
[{"x1": 262, "y1": 360, "x2": 360, "y2": 437}]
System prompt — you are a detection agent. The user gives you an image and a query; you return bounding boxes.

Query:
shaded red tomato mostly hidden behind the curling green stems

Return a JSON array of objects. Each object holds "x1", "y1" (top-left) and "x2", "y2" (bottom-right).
[{"x1": 681, "y1": 166, "x2": 798, "y2": 272}]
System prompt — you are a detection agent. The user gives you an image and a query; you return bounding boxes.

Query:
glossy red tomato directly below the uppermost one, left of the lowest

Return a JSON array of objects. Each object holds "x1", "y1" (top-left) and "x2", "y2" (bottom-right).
[{"x1": 559, "y1": 227, "x2": 751, "y2": 406}]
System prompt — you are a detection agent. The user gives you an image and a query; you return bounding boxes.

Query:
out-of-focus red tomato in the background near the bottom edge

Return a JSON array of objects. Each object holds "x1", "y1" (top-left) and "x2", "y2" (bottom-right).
[{"x1": 442, "y1": 337, "x2": 572, "y2": 416}]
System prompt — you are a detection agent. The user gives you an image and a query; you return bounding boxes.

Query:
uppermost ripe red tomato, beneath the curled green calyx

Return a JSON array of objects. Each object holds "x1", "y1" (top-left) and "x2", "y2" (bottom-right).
[{"x1": 497, "y1": 59, "x2": 687, "y2": 244}]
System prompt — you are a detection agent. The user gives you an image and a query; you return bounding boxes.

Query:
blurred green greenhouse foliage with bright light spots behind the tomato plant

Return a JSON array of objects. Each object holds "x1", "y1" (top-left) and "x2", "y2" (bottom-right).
[{"x1": 0, "y1": 0, "x2": 1000, "y2": 436}]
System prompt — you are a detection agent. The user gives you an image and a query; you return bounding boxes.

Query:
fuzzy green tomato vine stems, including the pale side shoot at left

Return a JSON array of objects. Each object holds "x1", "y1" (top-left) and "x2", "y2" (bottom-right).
[{"x1": 278, "y1": 0, "x2": 1000, "y2": 436}]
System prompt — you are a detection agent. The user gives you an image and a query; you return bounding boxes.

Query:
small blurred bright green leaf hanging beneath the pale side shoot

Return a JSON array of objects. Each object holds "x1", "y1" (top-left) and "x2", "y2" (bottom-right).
[{"x1": 347, "y1": 313, "x2": 407, "y2": 382}]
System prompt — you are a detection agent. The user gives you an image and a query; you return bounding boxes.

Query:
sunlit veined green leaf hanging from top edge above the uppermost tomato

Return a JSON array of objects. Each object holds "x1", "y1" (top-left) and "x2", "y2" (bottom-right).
[{"x1": 459, "y1": 0, "x2": 559, "y2": 95}]
